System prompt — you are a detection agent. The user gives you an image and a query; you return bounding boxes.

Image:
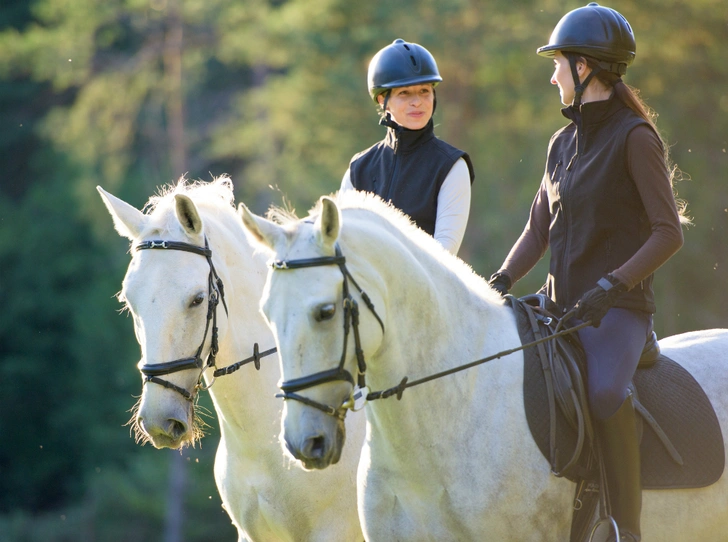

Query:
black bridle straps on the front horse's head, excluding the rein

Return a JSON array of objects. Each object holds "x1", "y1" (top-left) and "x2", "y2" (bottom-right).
[{"x1": 270, "y1": 245, "x2": 384, "y2": 419}]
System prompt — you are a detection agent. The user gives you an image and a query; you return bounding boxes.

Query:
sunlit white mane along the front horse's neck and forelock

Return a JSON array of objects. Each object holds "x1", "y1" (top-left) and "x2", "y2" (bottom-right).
[{"x1": 268, "y1": 190, "x2": 496, "y2": 302}]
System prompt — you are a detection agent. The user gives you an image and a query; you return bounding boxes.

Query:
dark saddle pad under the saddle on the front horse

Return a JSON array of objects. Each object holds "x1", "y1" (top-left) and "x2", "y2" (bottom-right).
[{"x1": 516, "y1": 311, "x2": 725, "y2": 489}]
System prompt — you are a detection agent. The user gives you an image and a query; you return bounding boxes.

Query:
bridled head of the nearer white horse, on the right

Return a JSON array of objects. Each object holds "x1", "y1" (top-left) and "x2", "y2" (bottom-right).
[{"x1": 238, "y1": 197, "x2": 384, "y2": 469}]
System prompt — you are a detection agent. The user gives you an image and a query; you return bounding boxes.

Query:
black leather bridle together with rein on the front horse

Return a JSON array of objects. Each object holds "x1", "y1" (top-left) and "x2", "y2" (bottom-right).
[{"x1": 269, "y1": 244, "x2": 591, "y2": 419}]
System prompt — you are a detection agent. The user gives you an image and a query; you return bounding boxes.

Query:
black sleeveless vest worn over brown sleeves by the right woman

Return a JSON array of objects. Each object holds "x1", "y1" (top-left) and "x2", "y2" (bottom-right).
[{"x1": 543, "y1": 97, "x2": 655, "y2": 313}]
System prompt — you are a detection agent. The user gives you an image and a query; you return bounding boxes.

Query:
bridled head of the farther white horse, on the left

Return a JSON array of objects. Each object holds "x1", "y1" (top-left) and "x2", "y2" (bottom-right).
[{"x1": 98, "y1": 183, "x2": 232, "y2": 448}]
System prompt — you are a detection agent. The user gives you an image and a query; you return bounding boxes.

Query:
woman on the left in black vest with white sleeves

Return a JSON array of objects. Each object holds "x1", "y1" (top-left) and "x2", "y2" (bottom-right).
[{"x1": 341, "y1": 39, "x2": 474, "y2": 254}]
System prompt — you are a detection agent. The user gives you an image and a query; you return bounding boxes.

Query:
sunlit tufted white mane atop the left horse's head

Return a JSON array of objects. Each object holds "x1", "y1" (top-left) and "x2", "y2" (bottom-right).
[{"x1": 143, "y1": 175, "x2": 235, "y2": 238}]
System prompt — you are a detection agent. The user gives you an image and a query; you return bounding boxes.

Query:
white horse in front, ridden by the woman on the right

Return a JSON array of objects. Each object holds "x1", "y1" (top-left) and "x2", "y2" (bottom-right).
[{"x1": 239, "y1": 192, "x2": 728, "y2": 542}]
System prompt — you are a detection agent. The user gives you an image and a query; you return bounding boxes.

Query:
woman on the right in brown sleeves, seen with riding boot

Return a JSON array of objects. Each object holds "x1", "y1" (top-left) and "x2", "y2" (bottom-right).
[{"x1": 490, "y1": 3, "x2": 687, "y2": 542}]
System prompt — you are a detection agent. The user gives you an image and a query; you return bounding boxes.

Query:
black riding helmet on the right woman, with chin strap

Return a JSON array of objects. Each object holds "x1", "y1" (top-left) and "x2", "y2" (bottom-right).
[{"x1": 536, "y1": 2, "x2": 636, "y2": 106}]
